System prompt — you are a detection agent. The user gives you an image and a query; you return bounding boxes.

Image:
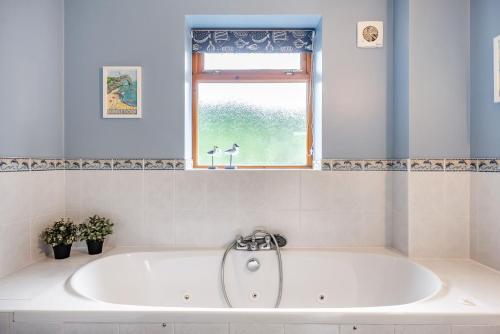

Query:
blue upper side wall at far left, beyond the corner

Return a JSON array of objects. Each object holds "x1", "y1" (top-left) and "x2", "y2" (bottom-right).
[{"x1": 0, "y1": 0, "x2": 64, "y2": 157}]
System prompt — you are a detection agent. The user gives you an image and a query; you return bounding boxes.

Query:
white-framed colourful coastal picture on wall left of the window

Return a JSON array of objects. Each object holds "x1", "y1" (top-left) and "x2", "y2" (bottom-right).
[{"x1": 102, "y1": 66, "x2": 142, "y2": 118}]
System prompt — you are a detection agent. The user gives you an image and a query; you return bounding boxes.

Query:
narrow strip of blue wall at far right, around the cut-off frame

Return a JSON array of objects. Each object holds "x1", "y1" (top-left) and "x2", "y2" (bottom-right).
[{"x1": 470, "y1": 0, "x2": 500, "y2": 157}]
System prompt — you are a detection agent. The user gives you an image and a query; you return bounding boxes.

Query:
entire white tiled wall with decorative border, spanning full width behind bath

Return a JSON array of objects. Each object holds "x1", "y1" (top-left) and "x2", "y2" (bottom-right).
[{"x1": 0, "y1": 159, "x2": 500, "y2": 276}]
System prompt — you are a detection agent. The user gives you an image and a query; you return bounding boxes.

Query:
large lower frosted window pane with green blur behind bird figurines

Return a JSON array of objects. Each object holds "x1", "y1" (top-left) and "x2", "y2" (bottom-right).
[{"x1": 198, "y1": 83, "x2": 307, "y2": 166}]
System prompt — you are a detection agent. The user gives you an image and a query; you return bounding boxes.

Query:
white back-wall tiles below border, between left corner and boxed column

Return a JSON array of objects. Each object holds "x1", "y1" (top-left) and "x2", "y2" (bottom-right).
[{"x1": 66, "y1": 170, "x2": 391, "y2": 247}]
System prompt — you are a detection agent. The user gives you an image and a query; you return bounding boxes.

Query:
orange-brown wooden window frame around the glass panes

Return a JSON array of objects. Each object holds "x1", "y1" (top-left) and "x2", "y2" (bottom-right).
[{"x1": 191, "y1": 52, "x2": 313, "y2": 169}]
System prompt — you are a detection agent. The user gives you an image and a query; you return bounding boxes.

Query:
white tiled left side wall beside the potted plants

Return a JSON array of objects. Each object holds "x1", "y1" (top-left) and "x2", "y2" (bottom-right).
[{"x1": 0, "y1": 170, "x2": 65, "y2": 277}]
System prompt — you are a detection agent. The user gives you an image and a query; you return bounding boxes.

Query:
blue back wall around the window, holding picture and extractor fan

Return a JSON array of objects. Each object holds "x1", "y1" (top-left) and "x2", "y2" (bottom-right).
[{"x1": 65, "y1": 0, "x2": 392, "y2": 158}]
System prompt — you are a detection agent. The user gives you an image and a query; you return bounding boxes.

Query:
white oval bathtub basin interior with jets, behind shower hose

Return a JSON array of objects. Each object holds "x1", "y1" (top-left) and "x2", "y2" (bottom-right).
[{"x1": 70, "y1": 250, "x2": 441, "y2": 309}]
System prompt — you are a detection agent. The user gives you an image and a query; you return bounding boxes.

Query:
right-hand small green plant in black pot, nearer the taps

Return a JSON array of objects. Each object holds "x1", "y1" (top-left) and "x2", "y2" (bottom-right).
[{"x1": 80, "y1": 215, "x2": 113, "y2": 255}]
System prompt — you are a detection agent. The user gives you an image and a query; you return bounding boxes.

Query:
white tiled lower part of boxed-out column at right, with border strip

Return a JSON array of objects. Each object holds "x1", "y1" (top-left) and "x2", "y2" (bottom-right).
[{"x1": 392, "y1": 159, "x2": 470, "y2": 258}]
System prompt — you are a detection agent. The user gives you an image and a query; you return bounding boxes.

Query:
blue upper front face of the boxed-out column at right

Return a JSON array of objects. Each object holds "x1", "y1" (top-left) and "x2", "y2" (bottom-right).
[{"x1": 409, "y1": 0, "x2": 474, "y2": 158}]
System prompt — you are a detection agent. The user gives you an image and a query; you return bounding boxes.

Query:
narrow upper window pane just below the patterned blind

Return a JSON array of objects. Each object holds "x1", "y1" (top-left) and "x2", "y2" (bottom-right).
[{"x1": 203, "y1": 53, "x2": 300, "y2": 71}]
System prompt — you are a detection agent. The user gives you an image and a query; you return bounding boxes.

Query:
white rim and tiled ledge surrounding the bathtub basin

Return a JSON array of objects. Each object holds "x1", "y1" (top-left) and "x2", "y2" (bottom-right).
[{"x1": 0, "y1": 246, "x2": 500, "y2": 326}]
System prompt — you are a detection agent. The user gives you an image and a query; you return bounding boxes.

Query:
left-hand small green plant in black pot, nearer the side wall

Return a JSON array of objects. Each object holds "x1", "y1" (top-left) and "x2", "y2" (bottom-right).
[{"x1": 40, "y1": 218, "x2": 79, "y2": 259}]
